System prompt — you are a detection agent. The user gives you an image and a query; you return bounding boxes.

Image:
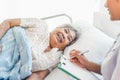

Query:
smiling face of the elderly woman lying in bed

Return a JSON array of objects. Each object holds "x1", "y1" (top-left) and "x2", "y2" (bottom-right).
[{"x1": 50, "y1": 28, "x2": 76, "y2": 50}]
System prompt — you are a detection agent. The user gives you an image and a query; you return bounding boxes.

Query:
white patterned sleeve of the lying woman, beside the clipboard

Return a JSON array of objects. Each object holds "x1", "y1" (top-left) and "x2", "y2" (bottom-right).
[{"x1": 32, "y1": 49, "x2": 62, "y2": 72}]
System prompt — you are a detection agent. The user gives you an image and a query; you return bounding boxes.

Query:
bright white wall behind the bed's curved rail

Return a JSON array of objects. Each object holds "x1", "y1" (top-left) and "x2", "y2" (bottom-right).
[{"x1": 0, "y1": 0, "x2": 99, "y2": 28}]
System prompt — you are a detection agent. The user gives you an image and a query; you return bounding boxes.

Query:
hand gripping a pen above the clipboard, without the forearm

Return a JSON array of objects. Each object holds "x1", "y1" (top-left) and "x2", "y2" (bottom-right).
[{"x1": 70, "y1": 50, "x2": 89, "y2": 69}]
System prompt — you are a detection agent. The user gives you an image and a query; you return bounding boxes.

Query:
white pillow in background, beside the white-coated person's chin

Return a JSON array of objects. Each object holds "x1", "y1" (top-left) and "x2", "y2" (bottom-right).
[{"x1": 94, "y1": 12, "x2": 120, "y2": 38}]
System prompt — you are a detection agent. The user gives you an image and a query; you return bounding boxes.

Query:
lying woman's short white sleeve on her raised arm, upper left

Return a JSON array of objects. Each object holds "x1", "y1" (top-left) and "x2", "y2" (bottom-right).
[{"x1": 20, "y1": 18, "x2": 47, "y2": 27}]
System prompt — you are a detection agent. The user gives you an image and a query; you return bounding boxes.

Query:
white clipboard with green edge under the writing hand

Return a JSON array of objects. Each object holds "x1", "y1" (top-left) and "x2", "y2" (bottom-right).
[{"x1": 58, "y1": 55, "x2": 98, "y2": 80}]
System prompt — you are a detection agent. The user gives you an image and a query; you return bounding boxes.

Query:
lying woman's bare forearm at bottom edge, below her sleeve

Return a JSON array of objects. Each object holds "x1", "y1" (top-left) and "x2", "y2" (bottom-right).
[{"x1": 26, "y1": 70, "x2": 49, "y2": 80}]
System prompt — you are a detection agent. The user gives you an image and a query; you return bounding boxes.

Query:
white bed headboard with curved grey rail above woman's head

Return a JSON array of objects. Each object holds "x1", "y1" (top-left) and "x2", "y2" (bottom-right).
[{"x1": 40, "y1": 13, "x2": 73, "y2": 31}]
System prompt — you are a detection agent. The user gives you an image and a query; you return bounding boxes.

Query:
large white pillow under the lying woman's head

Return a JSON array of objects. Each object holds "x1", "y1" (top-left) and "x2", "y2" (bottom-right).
[{"x1": 64, "y1": 21, "x2": 114, "y2": 64}]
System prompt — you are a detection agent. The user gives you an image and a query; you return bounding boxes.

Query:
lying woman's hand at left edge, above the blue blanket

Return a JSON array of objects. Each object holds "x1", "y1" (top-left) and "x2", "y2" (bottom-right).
[{"x1": 0, "y1": 20, "x2": 10, "y2": 39}]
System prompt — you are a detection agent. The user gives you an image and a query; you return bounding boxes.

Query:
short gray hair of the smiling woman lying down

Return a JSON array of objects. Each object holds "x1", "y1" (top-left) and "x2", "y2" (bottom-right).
[{"x1": 57, "y1": 24, "x2": 80, "y2": 46}]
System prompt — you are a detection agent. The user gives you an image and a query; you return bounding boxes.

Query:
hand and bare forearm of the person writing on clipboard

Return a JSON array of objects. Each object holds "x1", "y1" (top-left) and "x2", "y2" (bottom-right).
[{"x1": 70, "y1": 50, "x2": 101, "y2": 74}]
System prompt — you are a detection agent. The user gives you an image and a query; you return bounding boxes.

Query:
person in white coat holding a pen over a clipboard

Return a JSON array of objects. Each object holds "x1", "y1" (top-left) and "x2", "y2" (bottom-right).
[{"x1": 70, "y1": 0, "x2": 120, "y2": 80}]
